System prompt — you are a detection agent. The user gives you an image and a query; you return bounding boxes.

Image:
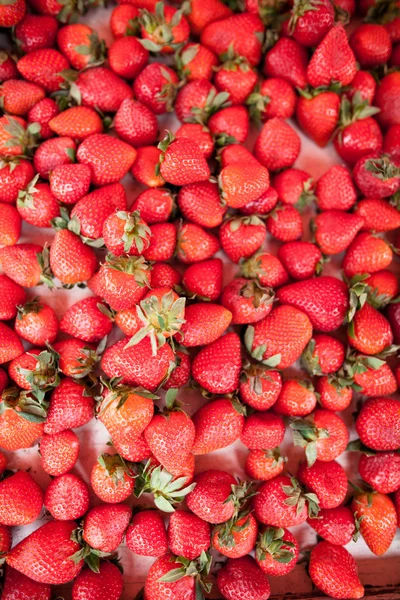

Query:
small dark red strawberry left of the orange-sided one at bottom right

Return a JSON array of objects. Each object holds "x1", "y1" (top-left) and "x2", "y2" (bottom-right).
[{"x1": 307, "y1": 506, "x2": 356, "y2": 546}]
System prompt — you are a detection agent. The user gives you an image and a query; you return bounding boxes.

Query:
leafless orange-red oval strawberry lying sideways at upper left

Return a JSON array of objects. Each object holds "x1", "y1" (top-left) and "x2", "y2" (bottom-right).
[{"x1": 49, "y1": 106, "x2": 103, "y2": 140}]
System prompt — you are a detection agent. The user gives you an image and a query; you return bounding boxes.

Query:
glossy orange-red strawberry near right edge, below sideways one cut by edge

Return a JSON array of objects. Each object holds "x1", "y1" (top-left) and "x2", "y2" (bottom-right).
[{"x1": 342, "y1": 233, "x2": 393, "y2": 278}]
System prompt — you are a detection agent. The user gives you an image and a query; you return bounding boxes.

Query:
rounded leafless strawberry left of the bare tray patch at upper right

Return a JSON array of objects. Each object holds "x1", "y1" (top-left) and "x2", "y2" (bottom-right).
[{"x1": 254, "y1": 118, "x2": 300, "y2": 171}]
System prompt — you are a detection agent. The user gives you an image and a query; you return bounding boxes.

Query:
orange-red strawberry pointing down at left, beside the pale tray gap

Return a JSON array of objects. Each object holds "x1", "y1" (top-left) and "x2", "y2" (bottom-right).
[{"x1": 50, "y1": 229, "x2": 97, "y2": 285}]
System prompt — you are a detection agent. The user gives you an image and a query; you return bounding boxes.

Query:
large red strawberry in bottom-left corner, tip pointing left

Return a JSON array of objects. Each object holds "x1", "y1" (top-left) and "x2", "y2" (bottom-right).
[{"x1": 6, "y1": 521, "x2": 83, "y2": 585}]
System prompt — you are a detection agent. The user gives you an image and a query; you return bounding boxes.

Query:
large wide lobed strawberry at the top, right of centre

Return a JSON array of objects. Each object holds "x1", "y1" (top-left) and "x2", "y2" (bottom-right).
[{"x1": 200, "y1": 13, "x2": 264, "y2": 66}]
